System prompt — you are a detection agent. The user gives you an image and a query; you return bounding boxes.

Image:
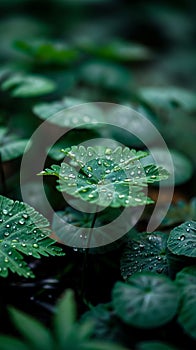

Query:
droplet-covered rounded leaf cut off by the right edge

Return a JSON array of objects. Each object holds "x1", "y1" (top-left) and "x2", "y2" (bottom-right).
[{"x1": 167, "y1": 221, "x2": 196, "y2": 258}]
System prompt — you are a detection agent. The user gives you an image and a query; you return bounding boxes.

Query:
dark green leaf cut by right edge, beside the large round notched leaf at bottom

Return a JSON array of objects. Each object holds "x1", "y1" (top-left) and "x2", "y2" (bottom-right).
[{"x1": 176, "y1": 266, "x2": 196, "y2": 339}]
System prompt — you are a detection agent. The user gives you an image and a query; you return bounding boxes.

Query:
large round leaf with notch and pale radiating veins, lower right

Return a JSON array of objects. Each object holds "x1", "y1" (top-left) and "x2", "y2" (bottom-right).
[{"x1": 112, "y1": 272, "x2": 179, "y2": 328}]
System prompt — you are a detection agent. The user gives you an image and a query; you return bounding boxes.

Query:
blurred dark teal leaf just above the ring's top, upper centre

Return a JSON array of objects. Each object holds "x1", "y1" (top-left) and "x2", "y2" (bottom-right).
[{"x1": 79, "y1": 60, "x2": 132, "y2": 91}]
